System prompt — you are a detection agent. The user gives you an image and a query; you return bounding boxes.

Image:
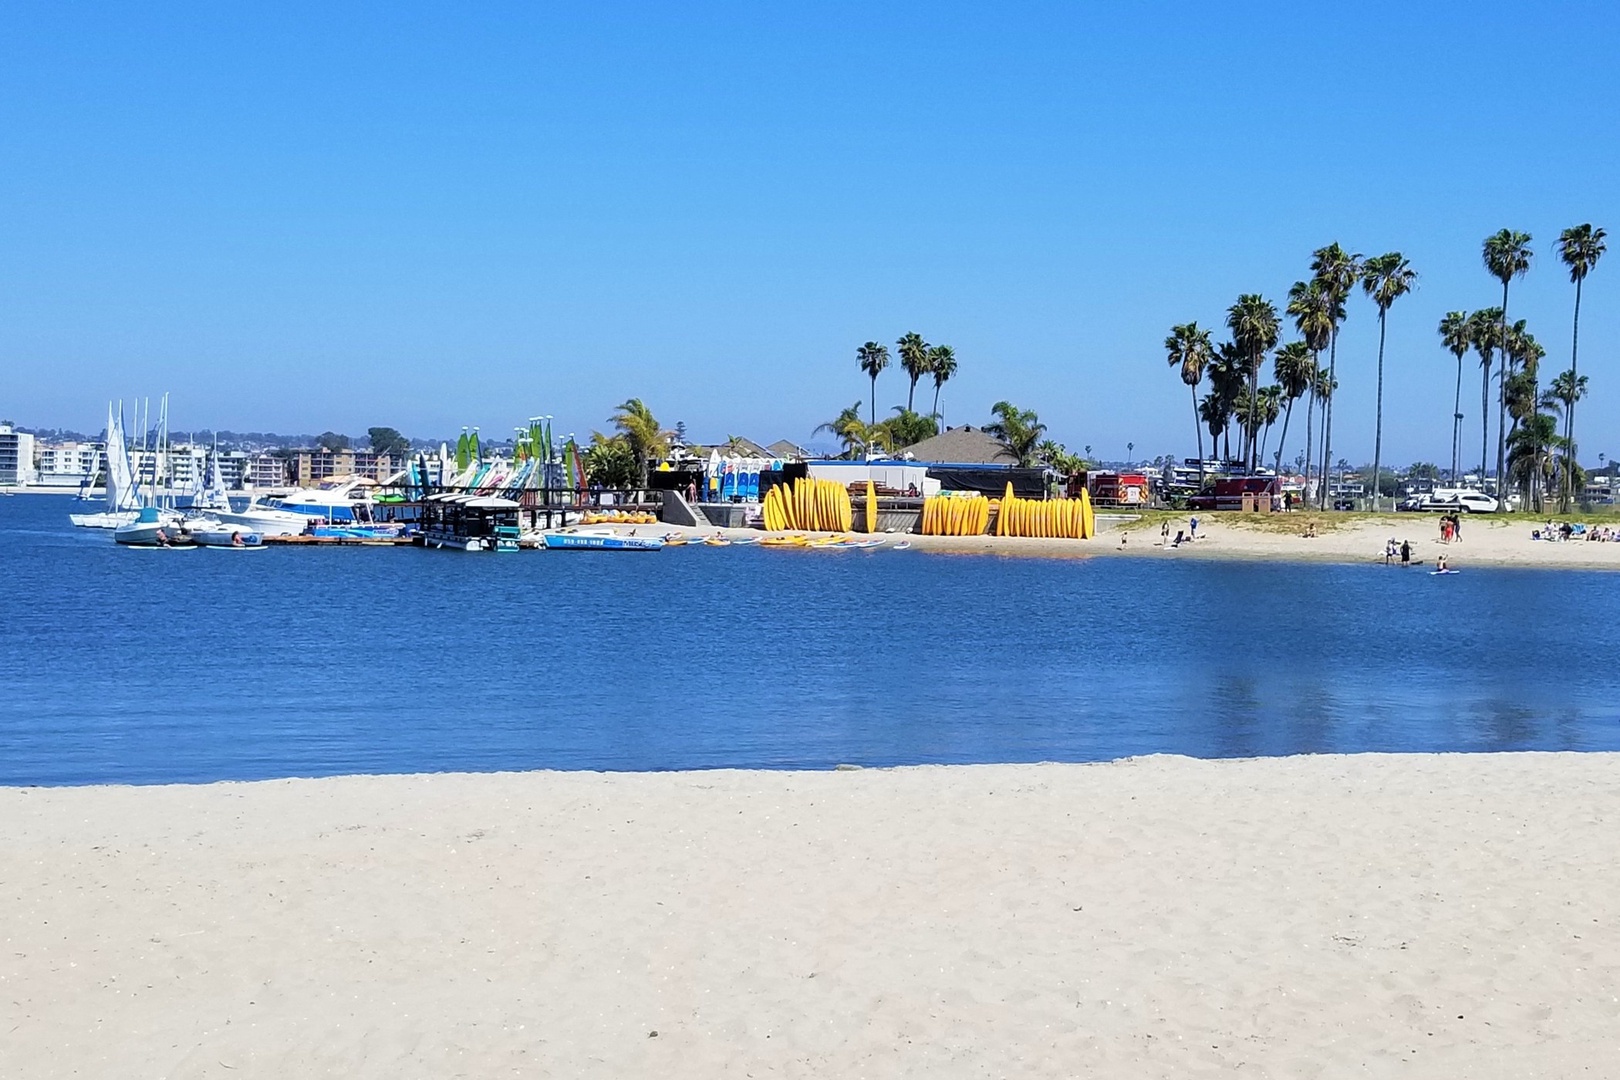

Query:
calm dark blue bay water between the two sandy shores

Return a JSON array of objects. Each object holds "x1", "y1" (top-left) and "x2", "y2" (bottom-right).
[{"x1": 0, "y1": 495, "x2": 1620, "y2": 784}]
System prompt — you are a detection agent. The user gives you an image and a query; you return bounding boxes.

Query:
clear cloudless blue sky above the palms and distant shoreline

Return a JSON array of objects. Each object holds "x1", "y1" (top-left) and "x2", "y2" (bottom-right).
[{"x1": 0, "y1": 0, "x2": 1620, "y2": 463}]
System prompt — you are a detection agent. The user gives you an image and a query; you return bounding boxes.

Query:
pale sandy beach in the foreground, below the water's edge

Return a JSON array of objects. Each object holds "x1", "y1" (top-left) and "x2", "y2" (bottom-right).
[{"x1": 0, "y1": 755, "x2": 1620, "y2": 1078}]
